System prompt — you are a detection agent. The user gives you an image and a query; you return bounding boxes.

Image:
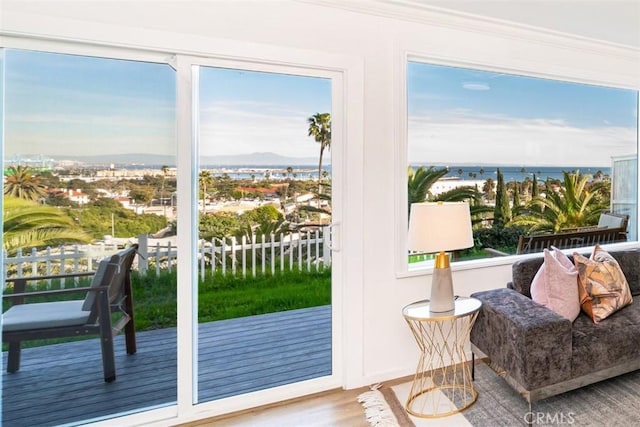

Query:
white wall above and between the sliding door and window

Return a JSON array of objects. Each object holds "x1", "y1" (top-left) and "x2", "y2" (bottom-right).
[{"x1": 0, "y1": 0, "x2": 640, "y2": 424}]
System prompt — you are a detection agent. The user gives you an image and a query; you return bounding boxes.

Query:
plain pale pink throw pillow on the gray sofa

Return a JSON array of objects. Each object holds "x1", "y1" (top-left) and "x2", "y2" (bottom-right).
[{"x1": 531, "y1": 246, "x2": 580, "y2": 322}]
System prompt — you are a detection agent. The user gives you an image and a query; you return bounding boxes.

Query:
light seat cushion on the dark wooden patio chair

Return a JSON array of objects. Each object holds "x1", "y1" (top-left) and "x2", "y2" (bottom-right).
[{"x1": 2, "y1": 300, "x2": 91, "y2": 331}]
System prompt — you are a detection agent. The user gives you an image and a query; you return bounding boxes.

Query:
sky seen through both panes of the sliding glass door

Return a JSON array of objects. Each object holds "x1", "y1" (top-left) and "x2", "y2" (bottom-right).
[{"x1": 5, "y1": 50, "x2": 331, "y2": 162}]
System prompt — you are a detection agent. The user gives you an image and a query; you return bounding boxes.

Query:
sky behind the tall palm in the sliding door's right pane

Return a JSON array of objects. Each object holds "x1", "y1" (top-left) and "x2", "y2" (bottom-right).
[{"x1": 200, "y1": 67, "x2": 331, "y2": 159}]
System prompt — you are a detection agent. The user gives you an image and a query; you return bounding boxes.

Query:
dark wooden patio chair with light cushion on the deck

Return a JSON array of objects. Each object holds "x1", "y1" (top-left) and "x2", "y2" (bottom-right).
[{"x1": 2, "y1": 245, "x2": 138, "y2": 382}]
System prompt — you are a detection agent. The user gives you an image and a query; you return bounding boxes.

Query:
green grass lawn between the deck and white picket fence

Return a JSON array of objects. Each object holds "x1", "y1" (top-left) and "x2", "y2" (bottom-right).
[{"x1": 3, "y1": 268, "x2": 331, "y2": 350}]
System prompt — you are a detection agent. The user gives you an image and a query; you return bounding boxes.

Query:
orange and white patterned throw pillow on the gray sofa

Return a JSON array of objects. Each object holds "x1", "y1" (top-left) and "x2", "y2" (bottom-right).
[{"x1": 573, "y1": 245, "x2": 633, "y2": 323}]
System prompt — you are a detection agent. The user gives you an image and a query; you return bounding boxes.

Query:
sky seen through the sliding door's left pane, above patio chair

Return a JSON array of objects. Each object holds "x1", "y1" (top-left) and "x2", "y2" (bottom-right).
[{"x1": 5, "y1": 50, "x2": 175, "y2": 156}]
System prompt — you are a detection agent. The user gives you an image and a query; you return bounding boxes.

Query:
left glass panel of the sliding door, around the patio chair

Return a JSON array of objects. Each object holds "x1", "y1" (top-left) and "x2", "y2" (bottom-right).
[{"x1": 2, "y1": 50, "x2": 176, "y2": 426}]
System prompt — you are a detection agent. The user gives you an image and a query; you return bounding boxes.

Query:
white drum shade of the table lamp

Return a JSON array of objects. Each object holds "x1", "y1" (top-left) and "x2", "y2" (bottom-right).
[{"x1": 408, "y1": 202, "x2": 473, "y2": 253}]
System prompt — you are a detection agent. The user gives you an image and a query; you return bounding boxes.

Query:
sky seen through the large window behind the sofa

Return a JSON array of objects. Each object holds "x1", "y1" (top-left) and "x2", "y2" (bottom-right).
[{"x1": 407, "y1": 62, "x2": 638, "y2": 167}]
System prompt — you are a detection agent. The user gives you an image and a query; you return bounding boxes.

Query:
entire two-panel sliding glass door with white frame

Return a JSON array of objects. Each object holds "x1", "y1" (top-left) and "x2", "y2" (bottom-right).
[{"x1": 2, "y1": 44, "x2": 344, "y2": 425}]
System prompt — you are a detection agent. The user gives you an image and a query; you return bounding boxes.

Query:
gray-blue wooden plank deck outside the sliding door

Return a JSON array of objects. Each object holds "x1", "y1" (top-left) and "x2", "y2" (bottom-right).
[{"x1": 2, "y1": 306, "x2": 331, "y2": 427}]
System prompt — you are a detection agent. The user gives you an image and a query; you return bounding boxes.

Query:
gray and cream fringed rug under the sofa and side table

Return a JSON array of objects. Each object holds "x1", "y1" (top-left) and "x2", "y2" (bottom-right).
[{"x1": 358, "y1": 363, "x2": 640, "y2": 427}]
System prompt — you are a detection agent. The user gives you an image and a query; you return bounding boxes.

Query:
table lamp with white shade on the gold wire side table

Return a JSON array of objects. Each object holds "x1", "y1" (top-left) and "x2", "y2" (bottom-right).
[{"x1": 408, "y1": 202, "x2": 473, "y2": 313}]
